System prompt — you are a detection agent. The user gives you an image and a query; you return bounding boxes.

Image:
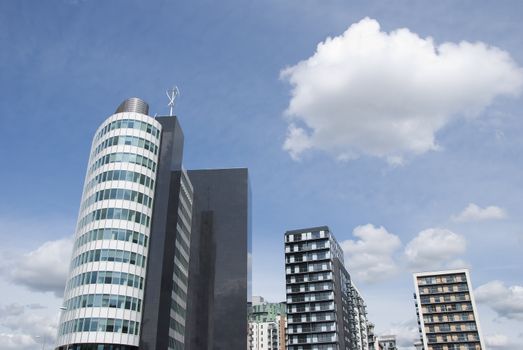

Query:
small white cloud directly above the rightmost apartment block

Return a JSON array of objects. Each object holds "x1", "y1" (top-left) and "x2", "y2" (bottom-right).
[{"x1": 405, "y1": 228, "x2": 467, "y2": 271}]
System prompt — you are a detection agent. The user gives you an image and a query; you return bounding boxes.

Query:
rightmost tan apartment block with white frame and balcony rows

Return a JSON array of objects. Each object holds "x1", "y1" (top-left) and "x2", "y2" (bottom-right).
[{"x1": 414, "y1": 269, "x2": 485, "y2": 350}]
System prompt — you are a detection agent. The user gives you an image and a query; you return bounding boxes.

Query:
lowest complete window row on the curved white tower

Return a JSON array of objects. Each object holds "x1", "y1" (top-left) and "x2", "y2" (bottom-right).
[{"x1": 58, "y1": 317, "x2": 140, "y2": 335}]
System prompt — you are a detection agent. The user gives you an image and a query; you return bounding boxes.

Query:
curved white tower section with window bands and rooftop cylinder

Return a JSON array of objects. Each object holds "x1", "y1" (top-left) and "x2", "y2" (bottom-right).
[{"x1": 57, "y1": 98, "x2": 162, "y2": 350}]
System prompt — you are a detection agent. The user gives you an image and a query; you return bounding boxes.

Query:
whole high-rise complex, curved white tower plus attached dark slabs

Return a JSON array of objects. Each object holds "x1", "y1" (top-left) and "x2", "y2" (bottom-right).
[{"x1": 57, "y1": 98, "x2": 250, "y2": 350}]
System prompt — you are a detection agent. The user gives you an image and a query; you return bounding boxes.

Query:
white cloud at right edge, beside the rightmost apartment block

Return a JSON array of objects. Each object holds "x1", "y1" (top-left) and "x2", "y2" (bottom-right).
[{"x1": 474, "y1": 281, "x2": 523, "y2": 321}]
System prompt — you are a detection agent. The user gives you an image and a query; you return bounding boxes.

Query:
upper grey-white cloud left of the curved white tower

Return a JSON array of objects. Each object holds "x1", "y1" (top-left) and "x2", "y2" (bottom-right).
[{"x1": 1, "y1": 238, "x2": 72, "y2": 297}]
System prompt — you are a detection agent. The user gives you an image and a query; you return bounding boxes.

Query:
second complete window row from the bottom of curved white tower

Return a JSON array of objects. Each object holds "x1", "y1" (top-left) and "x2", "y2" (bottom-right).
[{"x1": 64, "y1": 294, "x2": 142, "y2": 312}]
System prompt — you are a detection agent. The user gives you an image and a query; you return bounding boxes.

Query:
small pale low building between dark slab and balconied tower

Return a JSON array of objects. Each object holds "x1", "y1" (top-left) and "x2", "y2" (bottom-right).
[{"x1": 248, "y1": 296, "x2": 287, "y2": 350}]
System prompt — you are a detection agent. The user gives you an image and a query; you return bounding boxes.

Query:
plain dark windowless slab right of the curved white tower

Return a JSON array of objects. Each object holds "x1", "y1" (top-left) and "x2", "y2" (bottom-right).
[{"x1": 186, "y1": 168, "x2": 251, "y2": 350}]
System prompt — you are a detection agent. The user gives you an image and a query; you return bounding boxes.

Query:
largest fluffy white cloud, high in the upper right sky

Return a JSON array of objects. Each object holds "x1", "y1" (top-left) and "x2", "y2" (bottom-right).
[{"x1": 281, "y1": 18, "x2": 523, "y2": 164}]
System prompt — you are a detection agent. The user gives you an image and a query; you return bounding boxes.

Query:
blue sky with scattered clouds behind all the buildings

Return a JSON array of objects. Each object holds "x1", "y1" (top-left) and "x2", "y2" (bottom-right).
[{"x1": 0, "y1": 0, "x2": 523, "y2": 349}]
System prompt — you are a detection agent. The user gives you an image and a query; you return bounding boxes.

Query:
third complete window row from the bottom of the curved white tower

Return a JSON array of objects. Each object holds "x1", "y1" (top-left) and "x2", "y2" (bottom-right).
[{"x1": 67, "y1": 271, "x2": 143, "y2": 290}]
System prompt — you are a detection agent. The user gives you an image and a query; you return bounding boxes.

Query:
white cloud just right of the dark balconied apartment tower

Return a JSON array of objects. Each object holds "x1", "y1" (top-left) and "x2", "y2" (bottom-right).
[{"x1": 341, "y1": 224, "x2": 401, "y2": 282}]
